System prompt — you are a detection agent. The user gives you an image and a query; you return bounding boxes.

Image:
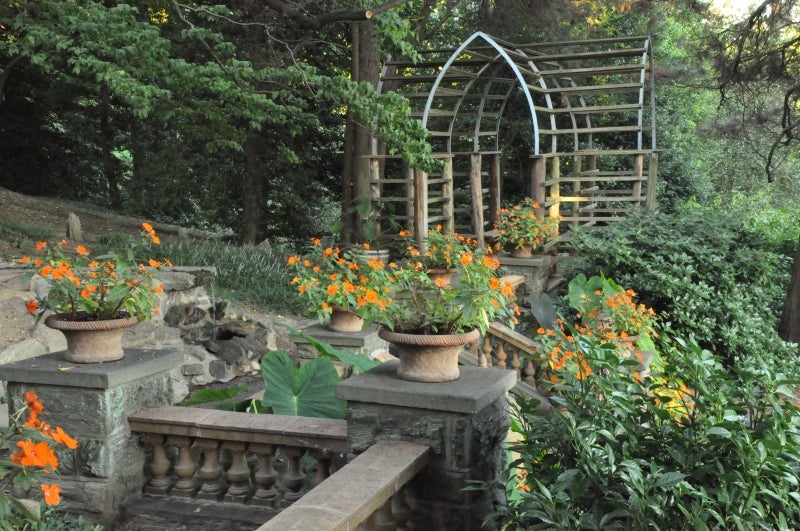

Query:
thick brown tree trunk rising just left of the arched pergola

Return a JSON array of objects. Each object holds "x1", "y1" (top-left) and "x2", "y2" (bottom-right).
[{"x1": 342, "y1": 22, "x2": 380, "y2": 242}]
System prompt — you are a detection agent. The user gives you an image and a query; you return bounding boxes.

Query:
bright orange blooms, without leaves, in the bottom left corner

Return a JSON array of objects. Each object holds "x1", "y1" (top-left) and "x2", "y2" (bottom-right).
[{"x1": 9, "y1": 391, "x2": 78, "y2": 505}]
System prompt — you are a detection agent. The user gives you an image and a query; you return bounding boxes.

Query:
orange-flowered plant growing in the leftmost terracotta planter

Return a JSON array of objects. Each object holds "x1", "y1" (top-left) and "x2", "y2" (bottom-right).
[{"x1": 17, "y1": 223, "x2": 172, "y2": 321}]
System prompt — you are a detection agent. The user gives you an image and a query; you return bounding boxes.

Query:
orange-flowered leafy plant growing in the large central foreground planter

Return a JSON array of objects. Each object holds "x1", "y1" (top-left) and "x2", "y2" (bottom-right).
[{"x1": 360, "y1": 250, "x2": 519, "y2": 334}]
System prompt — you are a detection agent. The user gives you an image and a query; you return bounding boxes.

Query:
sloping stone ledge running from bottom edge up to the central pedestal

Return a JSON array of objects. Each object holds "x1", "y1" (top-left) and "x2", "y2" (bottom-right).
[{"x1": 256, "y1": 441, "x2": 429, "y2": 531}]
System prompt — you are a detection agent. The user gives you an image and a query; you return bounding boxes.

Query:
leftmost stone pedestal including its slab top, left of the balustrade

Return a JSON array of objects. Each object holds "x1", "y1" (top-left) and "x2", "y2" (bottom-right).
[{"x1": 0, "y1": 349, "x2": 183, "y2": 524}]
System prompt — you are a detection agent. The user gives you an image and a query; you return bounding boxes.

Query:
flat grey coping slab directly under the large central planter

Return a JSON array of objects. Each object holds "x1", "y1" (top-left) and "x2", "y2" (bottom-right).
[{"x1": 336, "y1": 361, "x2": 517, "y2": 414}]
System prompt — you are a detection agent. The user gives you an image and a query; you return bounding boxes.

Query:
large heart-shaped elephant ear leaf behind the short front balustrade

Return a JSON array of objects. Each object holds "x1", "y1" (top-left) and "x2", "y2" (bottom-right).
[{"x1": 261, "y1": 351, "x2": 346, "y2": 419}]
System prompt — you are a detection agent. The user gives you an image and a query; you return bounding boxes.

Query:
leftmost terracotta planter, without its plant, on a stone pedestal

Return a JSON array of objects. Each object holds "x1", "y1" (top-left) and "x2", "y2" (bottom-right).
[{"x1": 44, "y1": 314, "x2": 139, "y2": 363}]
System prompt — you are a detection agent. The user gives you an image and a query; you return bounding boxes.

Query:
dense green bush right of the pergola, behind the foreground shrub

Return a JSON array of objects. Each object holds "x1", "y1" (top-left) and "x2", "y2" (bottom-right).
[{"x1": 573, "y1": 210, "x2": 795, "y2": 372}]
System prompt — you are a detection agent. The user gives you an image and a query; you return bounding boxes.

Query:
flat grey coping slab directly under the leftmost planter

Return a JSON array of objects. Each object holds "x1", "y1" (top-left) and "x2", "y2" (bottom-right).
[{"x1": 0, "y1": 348, "x2": 183, "y2": 389}]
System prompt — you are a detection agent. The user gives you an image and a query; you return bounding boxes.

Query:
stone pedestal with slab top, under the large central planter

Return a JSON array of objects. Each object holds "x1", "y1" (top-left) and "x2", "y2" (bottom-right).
[{"x1": 336, "y1": 361, "x2": 516, "y2": 531}]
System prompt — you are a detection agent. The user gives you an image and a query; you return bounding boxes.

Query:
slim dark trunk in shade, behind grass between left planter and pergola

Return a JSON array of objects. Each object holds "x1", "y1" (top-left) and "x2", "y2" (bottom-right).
[{"x1": 239, "y1": 136, "x2": 264, "y2": 243}]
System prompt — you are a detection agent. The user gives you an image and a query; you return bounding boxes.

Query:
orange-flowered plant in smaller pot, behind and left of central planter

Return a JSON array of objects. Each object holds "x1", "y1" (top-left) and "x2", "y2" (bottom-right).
[{"x1": 288, "y1": 242, "x2": 391, "y2": 320}]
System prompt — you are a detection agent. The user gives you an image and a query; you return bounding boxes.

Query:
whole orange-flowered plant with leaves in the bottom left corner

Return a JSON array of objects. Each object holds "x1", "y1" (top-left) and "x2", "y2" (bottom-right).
[{"x1": 0, "y1": 391, "x2": 78, "y2": 529}]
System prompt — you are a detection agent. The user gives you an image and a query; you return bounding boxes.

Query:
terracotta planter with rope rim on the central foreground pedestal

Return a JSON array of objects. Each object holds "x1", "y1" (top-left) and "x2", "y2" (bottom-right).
[{"x1": 378, "y1": 328, "x2": 481, "y2": 383}]
